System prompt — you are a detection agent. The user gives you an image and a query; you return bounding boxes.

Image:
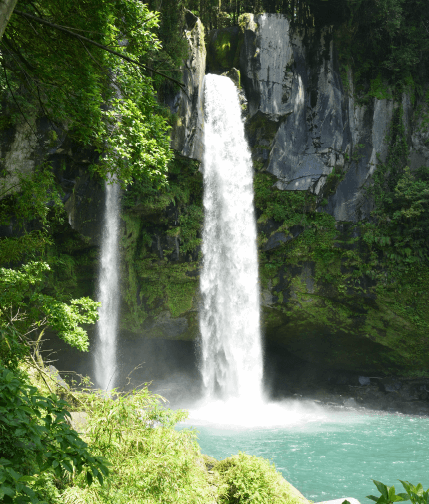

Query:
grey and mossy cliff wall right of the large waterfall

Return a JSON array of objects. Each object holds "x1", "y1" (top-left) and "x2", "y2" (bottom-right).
[{"x1": 171, "y1": 14, "x2": 429, "y2": 373}]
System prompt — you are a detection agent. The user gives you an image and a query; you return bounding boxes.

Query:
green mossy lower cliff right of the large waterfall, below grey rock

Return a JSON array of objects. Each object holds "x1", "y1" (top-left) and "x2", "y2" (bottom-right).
[{"x1": 254, "y1": 171, "x2": 429, "y2": 376}]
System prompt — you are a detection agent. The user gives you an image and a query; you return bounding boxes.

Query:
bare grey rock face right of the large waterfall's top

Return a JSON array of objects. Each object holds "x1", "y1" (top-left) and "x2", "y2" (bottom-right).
[{"x1": 240, "y1": 14, "x2": 414, "y2": 222}]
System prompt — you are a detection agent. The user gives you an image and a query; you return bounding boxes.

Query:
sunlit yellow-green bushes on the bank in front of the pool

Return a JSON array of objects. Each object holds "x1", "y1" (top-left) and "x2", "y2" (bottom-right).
[{"x1": 22, "y1": 366, "x2": 307, "y2": 504}]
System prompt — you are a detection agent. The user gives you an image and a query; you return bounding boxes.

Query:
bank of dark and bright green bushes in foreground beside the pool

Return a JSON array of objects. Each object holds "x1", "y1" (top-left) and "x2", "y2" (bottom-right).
[{"x1": 0, "y1": 367, "x2": 314, "y2": 504}]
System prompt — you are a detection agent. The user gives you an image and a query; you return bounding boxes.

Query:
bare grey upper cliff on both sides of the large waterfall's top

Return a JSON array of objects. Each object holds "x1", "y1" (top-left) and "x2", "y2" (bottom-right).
[{"x1": 196, "y1": 14, "x2": 429, "y2": 222}]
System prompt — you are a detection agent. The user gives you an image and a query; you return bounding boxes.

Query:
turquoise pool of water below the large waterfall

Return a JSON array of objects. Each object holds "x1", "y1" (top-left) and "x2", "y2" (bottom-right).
[{"x1": 182, "y1": 410, "x2": 429, "y2": 504}]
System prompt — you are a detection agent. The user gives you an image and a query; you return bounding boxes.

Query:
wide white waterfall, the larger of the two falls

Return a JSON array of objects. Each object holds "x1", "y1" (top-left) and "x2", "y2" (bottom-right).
[{"x1": 200, "y1": 74, "x2": 263, "y2": 401}]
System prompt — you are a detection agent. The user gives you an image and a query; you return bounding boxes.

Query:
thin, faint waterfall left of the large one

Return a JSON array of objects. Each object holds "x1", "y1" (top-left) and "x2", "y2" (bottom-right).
[{"x1": 94, "y1": 179, "x2": 120, "y2": 391}]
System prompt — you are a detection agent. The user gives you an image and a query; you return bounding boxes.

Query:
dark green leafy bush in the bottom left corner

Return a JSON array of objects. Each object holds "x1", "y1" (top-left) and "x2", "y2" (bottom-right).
[{"x1": 0, "y1": 366, "x2": 108, "y2": 504}]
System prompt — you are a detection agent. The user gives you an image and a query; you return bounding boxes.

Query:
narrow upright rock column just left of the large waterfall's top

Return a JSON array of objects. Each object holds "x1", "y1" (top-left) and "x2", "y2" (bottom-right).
[{"x1": 171, "y1": 11, "x2": 206, "y2": 161}]
